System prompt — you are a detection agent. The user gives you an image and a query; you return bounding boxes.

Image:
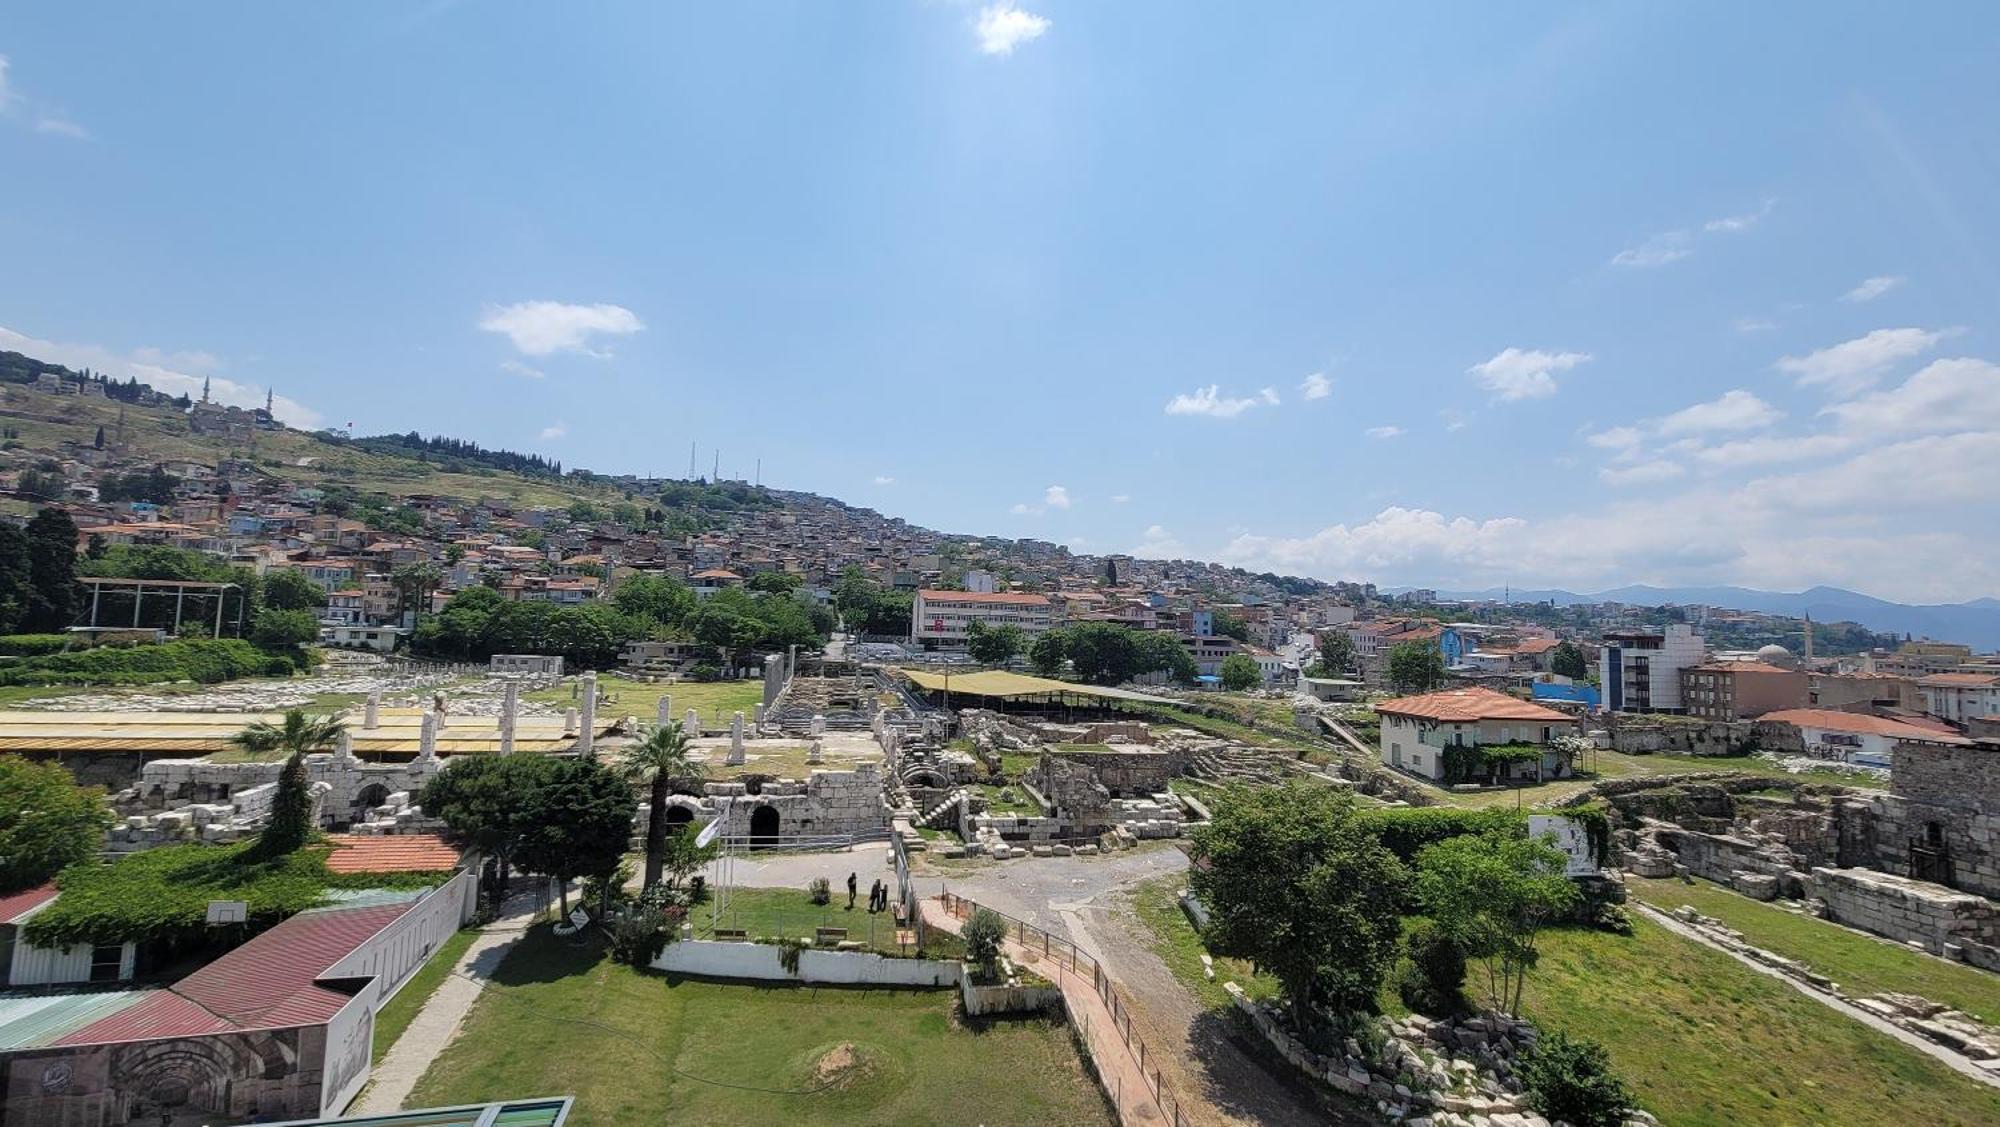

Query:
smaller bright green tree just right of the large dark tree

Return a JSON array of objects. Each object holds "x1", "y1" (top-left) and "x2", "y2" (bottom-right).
[{"x1": 1416, "y1": 831, "x2": 1578, "y2": 1013}]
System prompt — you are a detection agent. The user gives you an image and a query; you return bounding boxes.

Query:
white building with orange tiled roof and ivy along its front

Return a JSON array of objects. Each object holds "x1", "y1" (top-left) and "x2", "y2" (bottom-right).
[{"x1": 1376, "y1": 687, "x2": 1576, "y2": 779}]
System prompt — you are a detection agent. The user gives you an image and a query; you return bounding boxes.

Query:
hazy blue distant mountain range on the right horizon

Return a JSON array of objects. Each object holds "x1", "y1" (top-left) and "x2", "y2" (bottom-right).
[{"x1": 1438, "y1": 583, "x2": 2000, "y2": 649}]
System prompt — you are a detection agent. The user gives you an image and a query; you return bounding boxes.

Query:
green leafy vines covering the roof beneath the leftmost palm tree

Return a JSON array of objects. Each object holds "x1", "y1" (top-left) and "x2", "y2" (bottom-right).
[{"x1": 24, "y1": 839, "x2": 450, "y2": 949}]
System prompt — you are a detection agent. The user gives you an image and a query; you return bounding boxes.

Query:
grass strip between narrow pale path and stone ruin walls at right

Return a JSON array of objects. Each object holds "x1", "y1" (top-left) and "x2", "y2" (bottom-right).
[{"x1": 1626, "y1": 877, "x2": 2000, "y2": 1023}]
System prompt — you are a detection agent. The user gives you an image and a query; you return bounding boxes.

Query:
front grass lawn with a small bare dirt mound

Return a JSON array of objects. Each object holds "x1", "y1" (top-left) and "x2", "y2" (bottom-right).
[{"x1": 396, "y1": 929, "x2": 1112, "y2": 1127}]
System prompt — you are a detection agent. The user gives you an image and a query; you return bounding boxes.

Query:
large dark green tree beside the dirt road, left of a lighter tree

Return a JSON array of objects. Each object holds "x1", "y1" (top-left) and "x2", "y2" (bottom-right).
[{"x1": 1188, "y1": 783, "x2": 1408, "y2": 1031}]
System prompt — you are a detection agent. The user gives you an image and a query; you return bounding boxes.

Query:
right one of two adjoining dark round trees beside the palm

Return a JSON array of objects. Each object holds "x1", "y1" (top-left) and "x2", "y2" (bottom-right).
[{"x1": 510, "y1": 755, "x2": 634, "y2": 915}]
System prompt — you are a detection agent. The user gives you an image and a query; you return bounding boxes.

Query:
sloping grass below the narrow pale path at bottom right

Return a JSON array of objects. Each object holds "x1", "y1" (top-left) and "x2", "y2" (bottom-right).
[{"x1": 1524, "y1": 919, "x2": 2000, "y2": 1127}]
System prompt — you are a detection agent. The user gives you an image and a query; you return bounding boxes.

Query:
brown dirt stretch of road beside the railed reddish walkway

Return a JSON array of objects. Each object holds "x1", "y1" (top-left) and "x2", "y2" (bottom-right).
[{"x1": 1058, "y1": 893, "x2": 1372, "y2": 1127}]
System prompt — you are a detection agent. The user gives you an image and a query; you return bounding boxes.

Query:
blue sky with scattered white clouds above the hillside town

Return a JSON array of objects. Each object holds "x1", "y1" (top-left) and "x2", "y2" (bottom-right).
[{"x1": 0, "y1": 0, "x2": 2000, "y2": 599}]
